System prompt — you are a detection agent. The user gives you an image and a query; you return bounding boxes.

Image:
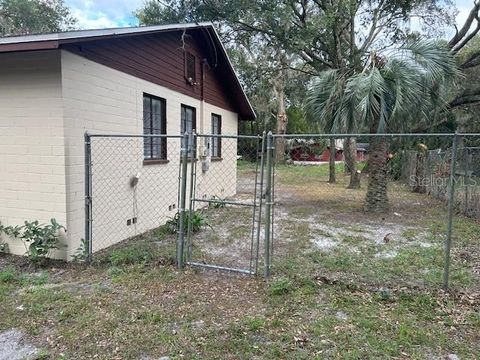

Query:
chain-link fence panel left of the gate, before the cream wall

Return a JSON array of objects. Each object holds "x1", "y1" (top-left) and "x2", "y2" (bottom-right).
[{"x1": 86, "y1": 135, "x2": 181, "y2": 253}]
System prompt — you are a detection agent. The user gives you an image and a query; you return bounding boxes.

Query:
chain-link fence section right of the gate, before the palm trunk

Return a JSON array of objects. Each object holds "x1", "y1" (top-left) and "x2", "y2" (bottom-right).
[{"x1": 273, "y1": 134, "x2": 480, "y2": 289}]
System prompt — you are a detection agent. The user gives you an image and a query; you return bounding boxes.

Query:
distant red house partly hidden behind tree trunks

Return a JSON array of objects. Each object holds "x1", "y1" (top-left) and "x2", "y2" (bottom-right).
[{"x1": 289, "y1": 139, "x2": 369, "y2": 162}]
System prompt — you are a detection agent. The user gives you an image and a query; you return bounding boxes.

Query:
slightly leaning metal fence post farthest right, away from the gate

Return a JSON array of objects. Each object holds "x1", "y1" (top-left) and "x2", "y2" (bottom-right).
[{"x1": 443, "y1": 133, "x2": 458, "y2": 290}]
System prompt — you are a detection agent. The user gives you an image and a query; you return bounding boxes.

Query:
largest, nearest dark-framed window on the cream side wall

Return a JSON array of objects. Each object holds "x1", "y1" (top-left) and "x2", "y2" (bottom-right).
[{"x1": 143, "y1": 94, "x2": 167, "y2": 160}]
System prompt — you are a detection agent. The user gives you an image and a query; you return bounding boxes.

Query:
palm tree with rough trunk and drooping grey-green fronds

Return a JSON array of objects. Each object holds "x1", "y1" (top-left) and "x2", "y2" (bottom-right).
[{"x1": 307, "y1": 40, "x2": 459, "y2": 212}]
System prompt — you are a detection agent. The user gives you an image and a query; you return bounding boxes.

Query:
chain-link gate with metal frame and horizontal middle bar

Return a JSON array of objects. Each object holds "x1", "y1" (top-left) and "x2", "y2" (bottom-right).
[{"x1": 178, "y1": 134, "x2": 269, "y2": 274}]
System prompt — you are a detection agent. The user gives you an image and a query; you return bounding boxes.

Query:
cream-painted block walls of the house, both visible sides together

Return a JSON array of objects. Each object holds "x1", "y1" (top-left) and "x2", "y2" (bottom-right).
[{"x1": 0, "y1": 50, "x2": 237, "y2": 259}]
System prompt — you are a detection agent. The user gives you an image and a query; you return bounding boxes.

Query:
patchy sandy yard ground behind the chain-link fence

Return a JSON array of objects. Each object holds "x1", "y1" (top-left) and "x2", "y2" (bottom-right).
[{"x1": 192, "y1": 165, "x2": 480, "y2": 289}]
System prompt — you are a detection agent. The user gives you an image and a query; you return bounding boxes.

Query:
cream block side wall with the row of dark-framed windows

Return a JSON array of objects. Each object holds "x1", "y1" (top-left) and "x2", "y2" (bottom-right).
[{"x1": 61, "y1": 51, "x2": 237, "y2": 255}]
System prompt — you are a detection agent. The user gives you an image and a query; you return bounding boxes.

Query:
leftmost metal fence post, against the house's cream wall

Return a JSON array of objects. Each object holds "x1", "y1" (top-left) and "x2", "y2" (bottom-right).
[{"x1": 84, "y1": 132, "x2": 93, "y2": 263}]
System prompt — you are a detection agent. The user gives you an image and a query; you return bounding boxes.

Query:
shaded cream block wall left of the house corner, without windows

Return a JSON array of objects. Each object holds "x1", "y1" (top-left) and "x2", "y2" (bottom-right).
[{"x1": 0, "y1": 51, "x2": 67, "y2": 257}]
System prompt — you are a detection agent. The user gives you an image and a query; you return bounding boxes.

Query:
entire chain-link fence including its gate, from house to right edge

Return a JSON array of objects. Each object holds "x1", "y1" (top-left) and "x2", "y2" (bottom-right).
[{"x1": 86, "y1": 134, "x2": 480, "y2": 287}]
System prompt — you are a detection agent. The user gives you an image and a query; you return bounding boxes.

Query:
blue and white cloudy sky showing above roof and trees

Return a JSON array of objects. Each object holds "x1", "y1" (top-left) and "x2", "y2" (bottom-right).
[{"x1": 65, "y1": 0, "x2": 474, "y2": 29}]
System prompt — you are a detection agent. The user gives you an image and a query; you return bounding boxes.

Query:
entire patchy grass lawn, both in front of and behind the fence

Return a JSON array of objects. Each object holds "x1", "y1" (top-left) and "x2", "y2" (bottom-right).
[{"x1": 0, "y1": 164, "x2": 480, "y2": 359}]
